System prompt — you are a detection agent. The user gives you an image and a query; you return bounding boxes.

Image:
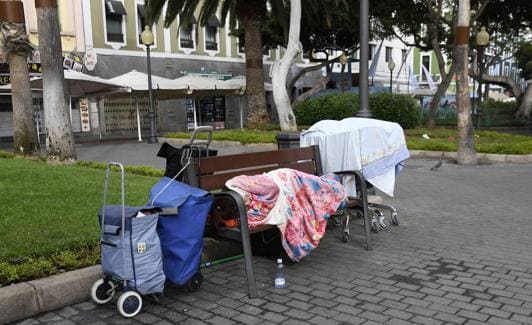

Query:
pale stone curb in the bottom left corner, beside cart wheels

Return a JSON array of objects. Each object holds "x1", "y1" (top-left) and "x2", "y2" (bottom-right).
[{"x1": 0, "y1": 265, "x2": 102, "y2": 324}]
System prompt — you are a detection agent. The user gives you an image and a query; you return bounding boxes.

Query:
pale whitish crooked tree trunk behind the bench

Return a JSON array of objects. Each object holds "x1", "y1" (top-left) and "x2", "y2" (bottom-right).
[{"x1": 271, "y1": 0, "x2": 301, "y2": 132}]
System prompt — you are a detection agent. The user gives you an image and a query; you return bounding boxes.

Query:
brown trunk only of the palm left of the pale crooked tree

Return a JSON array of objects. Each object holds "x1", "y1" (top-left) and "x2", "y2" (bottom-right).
[{"x1": 243, "y1": 16, "x2": 269, "y2": 127}]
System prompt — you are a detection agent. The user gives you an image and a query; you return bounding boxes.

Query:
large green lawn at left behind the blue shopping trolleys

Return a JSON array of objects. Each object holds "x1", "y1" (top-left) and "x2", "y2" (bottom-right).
[{"x1": 0, "y1": 158, "x2": 159, "y2": 285}]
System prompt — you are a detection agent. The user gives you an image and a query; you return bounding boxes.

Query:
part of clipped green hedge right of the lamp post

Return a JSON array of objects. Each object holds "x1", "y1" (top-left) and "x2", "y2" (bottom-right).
[{"x1": 369, "y1": 93, "x2": 421, "y2": 129}]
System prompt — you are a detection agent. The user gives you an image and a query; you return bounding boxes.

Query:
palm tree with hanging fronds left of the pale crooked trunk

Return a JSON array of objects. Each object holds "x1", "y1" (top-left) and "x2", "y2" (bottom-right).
[{"x1": 146, "y1": 0, "x2": 274, "y2": 126}]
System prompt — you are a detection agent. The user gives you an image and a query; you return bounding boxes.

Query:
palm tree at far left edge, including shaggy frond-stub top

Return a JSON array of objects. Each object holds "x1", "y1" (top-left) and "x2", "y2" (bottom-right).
[{"x1": 0, "y1": 6, "x2": 39, "y2": 155}]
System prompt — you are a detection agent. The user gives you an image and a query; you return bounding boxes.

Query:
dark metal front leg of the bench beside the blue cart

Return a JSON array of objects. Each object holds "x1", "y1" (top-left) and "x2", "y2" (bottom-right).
[{"x1": 224, "y1": 191, "x2": 258, "y2": 299}]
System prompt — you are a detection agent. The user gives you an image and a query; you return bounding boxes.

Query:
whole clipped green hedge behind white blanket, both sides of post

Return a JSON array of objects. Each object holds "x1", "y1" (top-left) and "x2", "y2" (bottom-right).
[{"x1": 294, "y1": 93, "x2": 421, "y2": 129}]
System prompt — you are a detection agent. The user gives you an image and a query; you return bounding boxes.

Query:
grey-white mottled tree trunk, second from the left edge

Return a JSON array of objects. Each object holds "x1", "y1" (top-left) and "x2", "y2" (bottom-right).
[{"x1": 35, "y1": 0, "x2": 76, "y2": 163}]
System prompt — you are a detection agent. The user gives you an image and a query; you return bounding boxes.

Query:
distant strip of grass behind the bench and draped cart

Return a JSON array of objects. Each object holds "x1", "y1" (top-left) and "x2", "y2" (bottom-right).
[{"x1": 165, "y1": 128, "x2": 532, "y2": 155}]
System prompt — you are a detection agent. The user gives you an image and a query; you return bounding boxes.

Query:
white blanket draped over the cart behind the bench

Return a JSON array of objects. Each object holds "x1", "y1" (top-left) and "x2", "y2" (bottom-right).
[{"x1": 300, "y1": 117, "x2": 409, "y2": 196}]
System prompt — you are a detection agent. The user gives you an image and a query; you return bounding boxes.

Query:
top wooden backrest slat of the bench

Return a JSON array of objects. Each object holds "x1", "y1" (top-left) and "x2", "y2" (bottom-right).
[{"x1": 199, "y1": 147, "x2": 315, "y2": 174}]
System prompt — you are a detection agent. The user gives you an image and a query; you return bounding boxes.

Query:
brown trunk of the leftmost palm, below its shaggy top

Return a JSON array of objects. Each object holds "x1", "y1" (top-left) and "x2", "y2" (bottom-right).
[{"x1": 7, "y1": 53, "x2": 39, "y2": 155}]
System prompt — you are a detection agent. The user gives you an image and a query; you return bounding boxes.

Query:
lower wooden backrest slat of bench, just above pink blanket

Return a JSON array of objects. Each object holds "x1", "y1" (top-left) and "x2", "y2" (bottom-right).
[{"x1": 199, "y1": 161, "x2": 316, "y2": 191}]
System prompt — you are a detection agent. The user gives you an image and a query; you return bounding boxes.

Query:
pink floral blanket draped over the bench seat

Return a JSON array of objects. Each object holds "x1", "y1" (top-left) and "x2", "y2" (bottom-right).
[{"x1": 226, "y1": 168, "x2": 346, "y2": 261}]
